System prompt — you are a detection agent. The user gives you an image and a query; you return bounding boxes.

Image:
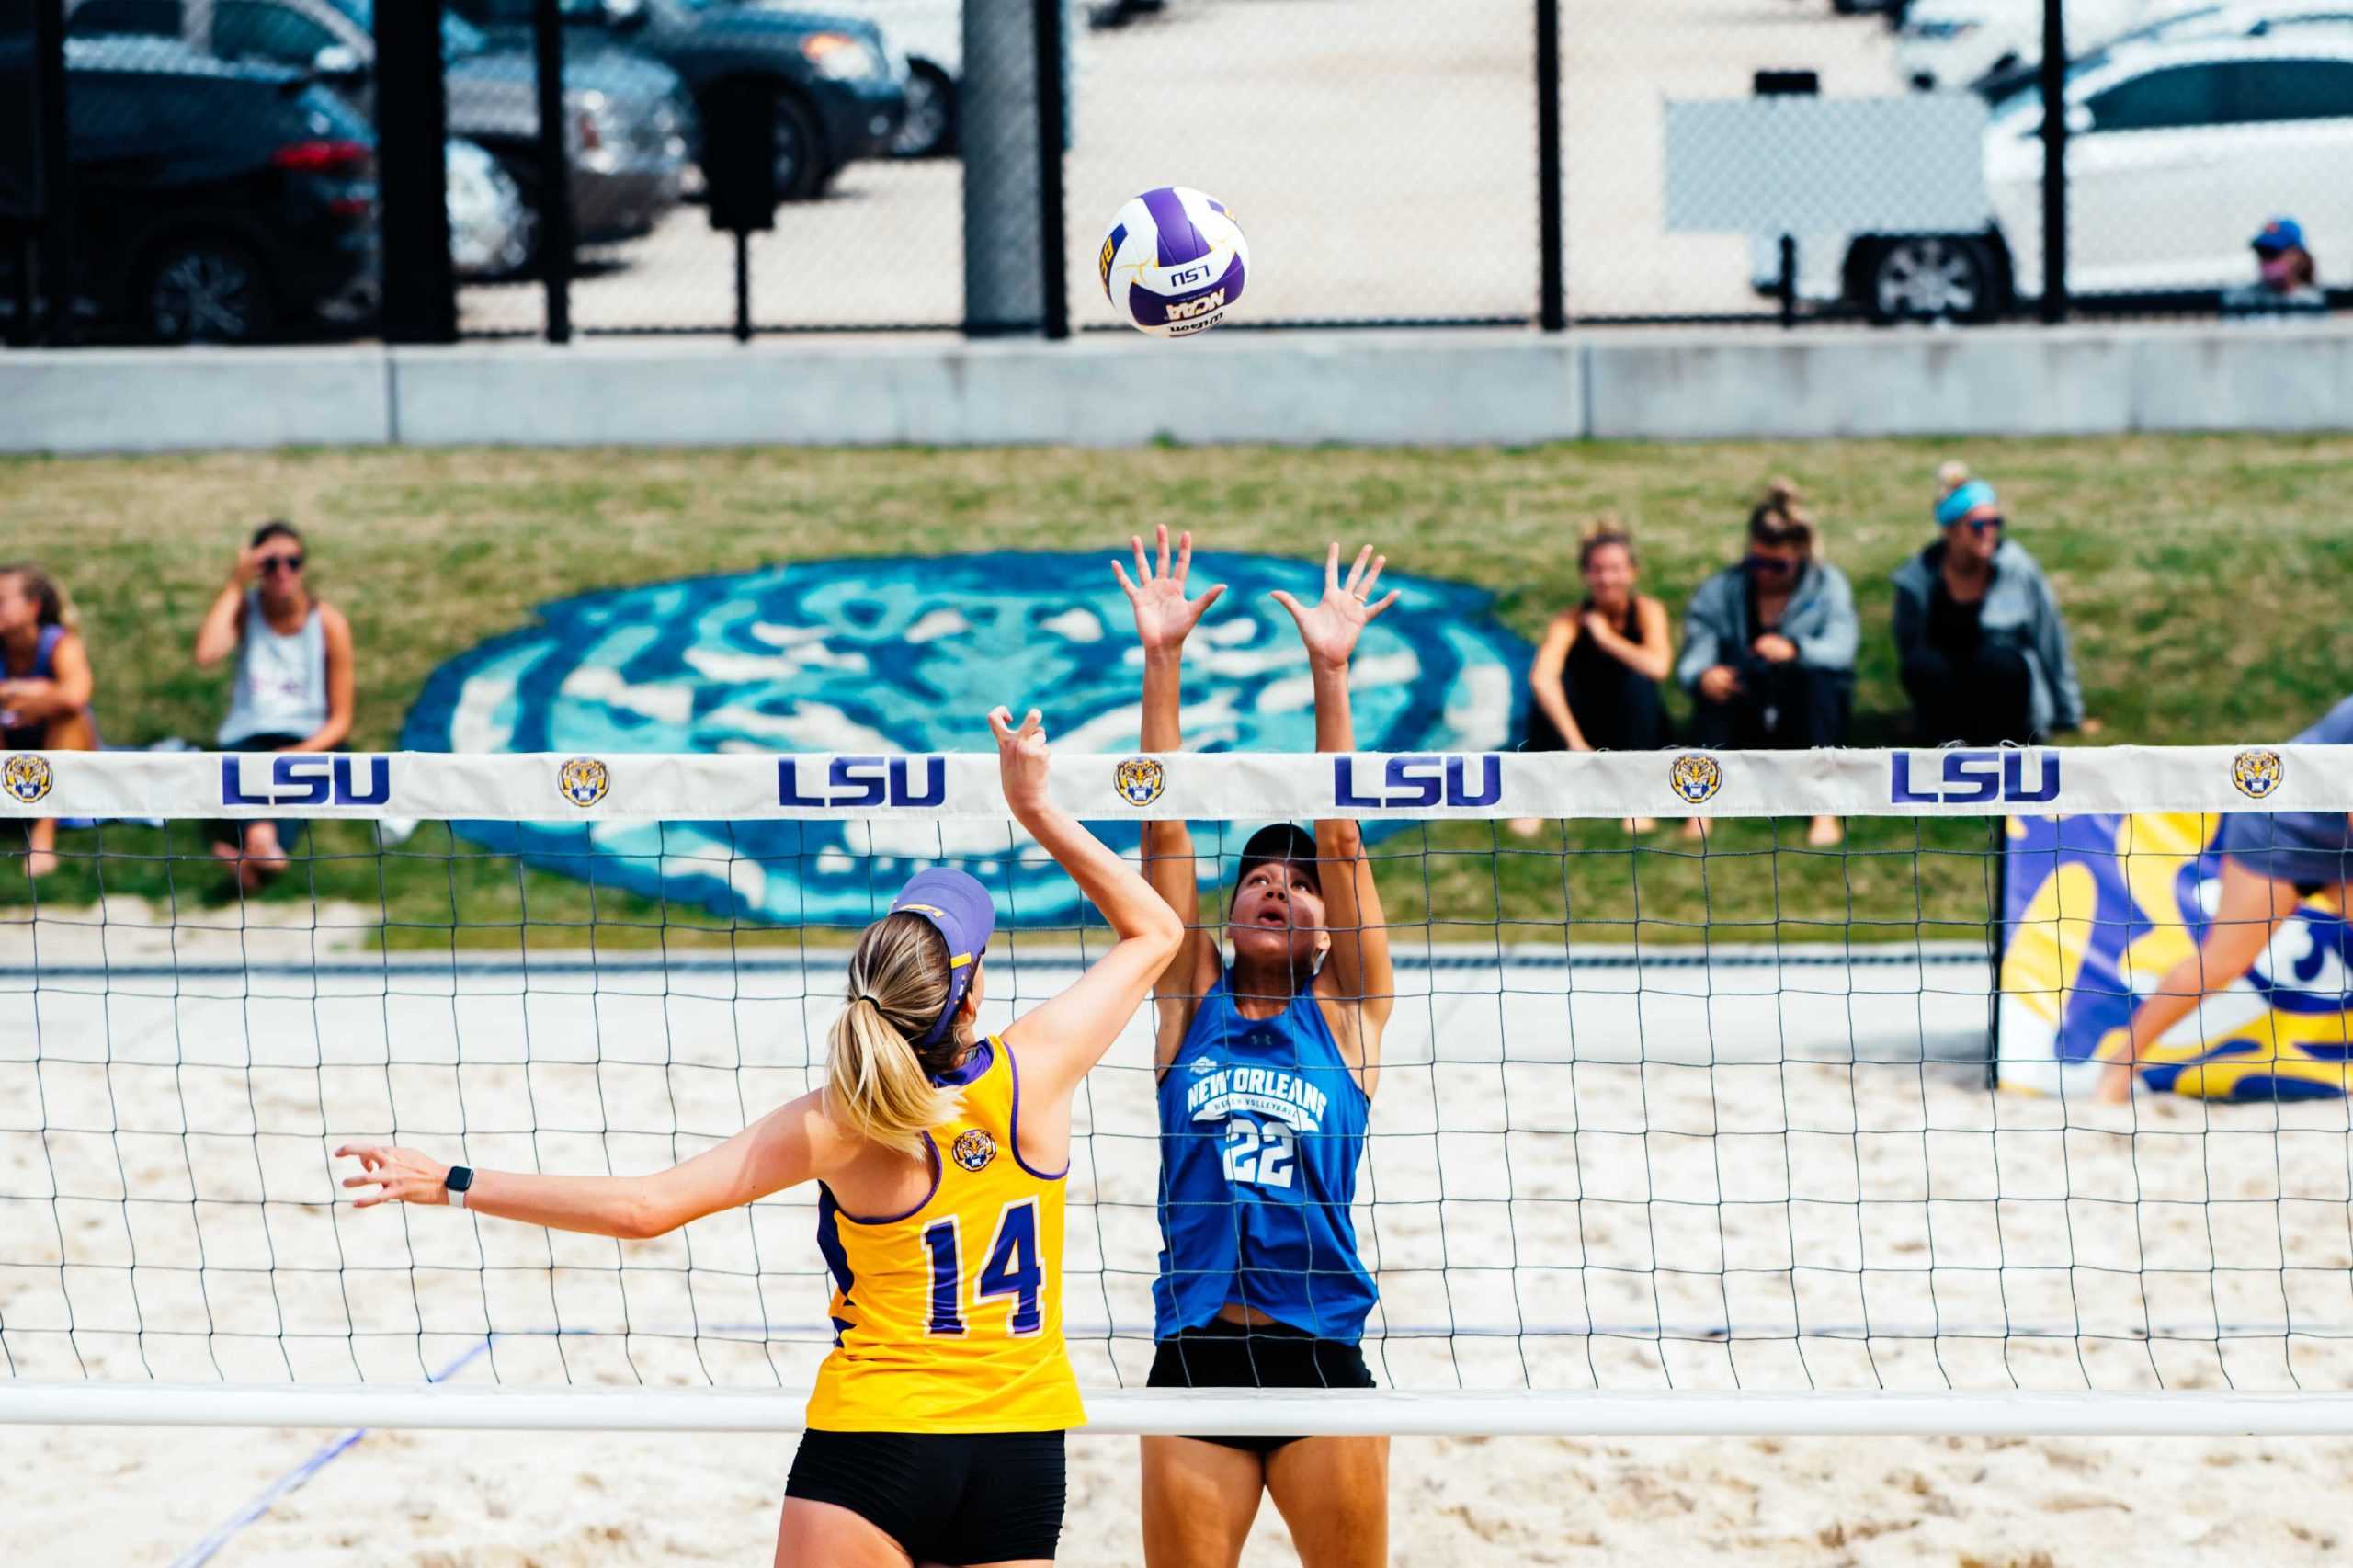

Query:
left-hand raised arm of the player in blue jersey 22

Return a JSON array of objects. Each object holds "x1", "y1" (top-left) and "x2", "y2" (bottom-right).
[{"x1": 1110, "y1": 525, "x2": 1226, "y2": 1074}]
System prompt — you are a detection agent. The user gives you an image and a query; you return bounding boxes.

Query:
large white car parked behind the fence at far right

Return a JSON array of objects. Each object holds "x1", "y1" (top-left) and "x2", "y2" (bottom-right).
[{"x1": 1800, "y1": 28, "x2": 2353, "y2": 320}]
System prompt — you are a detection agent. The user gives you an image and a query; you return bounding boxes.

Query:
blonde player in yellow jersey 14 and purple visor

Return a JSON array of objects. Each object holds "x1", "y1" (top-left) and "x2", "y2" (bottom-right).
[{"x1": 336, "y1": 709, "x2": 1184, "y2": 1568}]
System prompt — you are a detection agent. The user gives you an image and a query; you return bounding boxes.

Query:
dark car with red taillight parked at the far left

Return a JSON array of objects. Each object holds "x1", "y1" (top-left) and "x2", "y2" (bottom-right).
[{"x1": 0, "y1": 38, "x2": 377, "y2": 344}]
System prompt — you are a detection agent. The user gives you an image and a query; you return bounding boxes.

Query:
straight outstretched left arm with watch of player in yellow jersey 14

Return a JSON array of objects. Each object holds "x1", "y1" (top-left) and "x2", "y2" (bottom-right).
[{"x1": 335, "y1": 1095, "x2": 857, "y2": 1241}]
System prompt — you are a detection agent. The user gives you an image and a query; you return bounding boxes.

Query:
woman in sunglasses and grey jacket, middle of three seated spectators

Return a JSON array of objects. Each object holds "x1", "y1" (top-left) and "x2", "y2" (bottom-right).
[{"x1": 1676, "y1": 481, "x2": 1861, "y2": 847}]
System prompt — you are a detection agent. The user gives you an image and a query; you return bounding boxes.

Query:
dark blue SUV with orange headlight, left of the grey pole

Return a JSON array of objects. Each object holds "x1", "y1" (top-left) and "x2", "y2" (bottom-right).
[{"x1": 449, "y1": 0, "x2": 908, "y2": 200}]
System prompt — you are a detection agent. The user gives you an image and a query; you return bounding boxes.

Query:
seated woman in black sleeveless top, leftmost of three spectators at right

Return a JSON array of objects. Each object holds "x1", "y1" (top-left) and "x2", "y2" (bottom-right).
[{"x1": 1511, "y1": 513, "x2": 1676, "y2": 835}]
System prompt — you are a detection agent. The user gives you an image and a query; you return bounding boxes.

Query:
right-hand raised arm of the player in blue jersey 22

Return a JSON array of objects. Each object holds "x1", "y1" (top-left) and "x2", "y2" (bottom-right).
[{"x1": 1273, "y1": 544, "x2": 1398, "y2": 1068}]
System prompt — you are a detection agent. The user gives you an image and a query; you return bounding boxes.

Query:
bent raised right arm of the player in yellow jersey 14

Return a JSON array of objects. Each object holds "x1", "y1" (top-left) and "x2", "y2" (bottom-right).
[{"x1": 988, "y1": 709, "x2": 1184, "y2": 1096}]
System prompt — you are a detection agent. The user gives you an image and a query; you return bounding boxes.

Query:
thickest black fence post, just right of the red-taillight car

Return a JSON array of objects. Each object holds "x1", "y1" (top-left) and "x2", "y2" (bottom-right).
[{"x1": 377, "y1": 0, "x2": 457, "y2": 344}]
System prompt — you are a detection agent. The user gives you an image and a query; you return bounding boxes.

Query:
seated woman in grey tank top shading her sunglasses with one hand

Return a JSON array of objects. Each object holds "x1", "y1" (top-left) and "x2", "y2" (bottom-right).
[{"x1": 195, "y1": 520, "x2": 353, "y2": 892}]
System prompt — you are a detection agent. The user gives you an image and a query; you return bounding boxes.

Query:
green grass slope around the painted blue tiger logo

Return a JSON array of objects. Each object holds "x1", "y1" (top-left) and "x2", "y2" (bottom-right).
[{"x1": 0, "y1": 436, "x2": 2353, "y2": 947}]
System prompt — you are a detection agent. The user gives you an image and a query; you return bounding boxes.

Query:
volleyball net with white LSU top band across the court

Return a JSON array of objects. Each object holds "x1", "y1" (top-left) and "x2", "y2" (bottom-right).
[{"x1": 0, "y1": 746, "x2": 2353, "y2": 1431}]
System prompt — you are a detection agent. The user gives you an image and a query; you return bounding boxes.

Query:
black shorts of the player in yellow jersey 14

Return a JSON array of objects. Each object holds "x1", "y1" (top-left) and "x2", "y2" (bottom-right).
[{"x1": 783, "y1": 1431, "x2": 1066, "y2": 1563}]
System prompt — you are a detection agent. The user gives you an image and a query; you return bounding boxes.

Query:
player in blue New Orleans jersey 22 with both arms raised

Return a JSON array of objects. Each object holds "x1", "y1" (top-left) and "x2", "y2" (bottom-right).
[{"x1": 1113, "y1": 528, "x2": 1398, "y2": 1568}]
